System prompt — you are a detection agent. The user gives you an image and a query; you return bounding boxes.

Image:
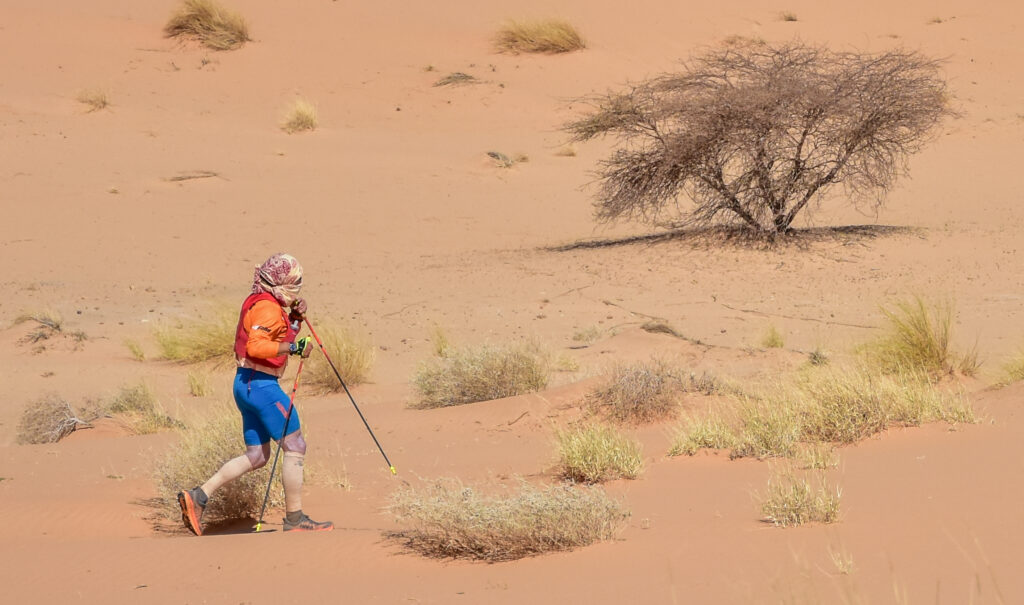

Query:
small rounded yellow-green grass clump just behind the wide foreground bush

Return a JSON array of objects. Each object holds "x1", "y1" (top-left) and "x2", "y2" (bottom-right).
[{"x1": 555, "y1": 426, "x2": 643, "y2": 483}]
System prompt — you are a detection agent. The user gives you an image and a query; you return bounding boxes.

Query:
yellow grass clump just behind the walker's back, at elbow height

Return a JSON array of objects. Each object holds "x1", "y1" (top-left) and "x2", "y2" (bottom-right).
[{"x1": 154, "y1": 306, "x2": 239, "y2": 363}]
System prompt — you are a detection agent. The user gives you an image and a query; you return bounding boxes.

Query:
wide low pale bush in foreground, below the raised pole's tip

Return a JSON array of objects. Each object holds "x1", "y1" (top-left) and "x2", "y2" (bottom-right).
[{"x1": 389, "y1": 479, "x2": 629, "y2": 562}]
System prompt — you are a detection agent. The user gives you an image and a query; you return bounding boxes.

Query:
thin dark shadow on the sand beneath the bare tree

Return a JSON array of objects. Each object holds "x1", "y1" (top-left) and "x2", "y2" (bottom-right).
[{"x1": 541, "y1": 225, "x2": 921, "y2": 252}]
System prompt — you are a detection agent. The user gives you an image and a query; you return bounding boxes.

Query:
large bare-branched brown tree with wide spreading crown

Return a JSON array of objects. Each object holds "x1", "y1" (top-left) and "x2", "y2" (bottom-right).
[{"x1": 564, "y1": 42, "x2": 954, "y2": 236}]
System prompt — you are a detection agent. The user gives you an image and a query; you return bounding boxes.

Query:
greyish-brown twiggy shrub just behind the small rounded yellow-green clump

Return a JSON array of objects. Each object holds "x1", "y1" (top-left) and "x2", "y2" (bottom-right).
[{"x1": 587, "y1": 359, "x2": 718, "y2": 423}]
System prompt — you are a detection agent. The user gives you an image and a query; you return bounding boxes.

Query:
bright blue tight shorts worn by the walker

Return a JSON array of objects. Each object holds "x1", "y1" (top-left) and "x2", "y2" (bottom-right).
[{"x1": 232, "y1": 368, "x2": 299, "y2": 445}]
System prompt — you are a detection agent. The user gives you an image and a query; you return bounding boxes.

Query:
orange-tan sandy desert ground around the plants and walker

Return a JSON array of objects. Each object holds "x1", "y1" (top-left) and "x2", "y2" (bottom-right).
[{"x1": 0, "y1": 0, "x2": 1024, "y2": 604}]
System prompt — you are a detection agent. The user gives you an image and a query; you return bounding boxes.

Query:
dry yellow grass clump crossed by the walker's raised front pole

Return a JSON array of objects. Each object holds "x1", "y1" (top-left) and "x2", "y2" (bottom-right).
[{"x1": 300, "y1": 323, "x2": 374, "y2": 394}]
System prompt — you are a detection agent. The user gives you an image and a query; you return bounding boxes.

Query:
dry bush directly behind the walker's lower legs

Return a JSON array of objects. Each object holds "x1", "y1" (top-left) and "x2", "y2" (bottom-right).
[{"x1": 154, "y1": 404, "x2": 285, "y2": 523}]
